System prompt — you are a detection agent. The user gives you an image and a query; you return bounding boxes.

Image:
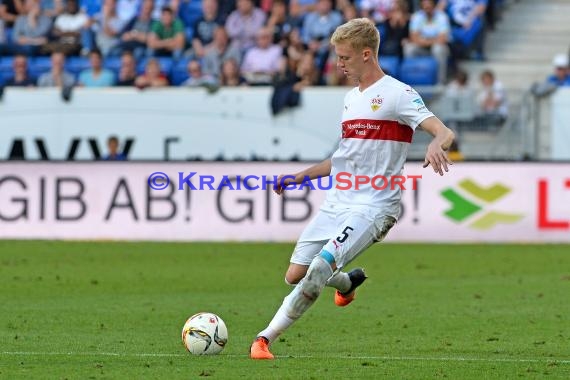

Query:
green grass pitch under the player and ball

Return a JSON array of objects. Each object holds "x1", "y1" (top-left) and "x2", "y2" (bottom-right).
[{"x1": 0, "y1": 241, "x2": 570, "y2": 379}]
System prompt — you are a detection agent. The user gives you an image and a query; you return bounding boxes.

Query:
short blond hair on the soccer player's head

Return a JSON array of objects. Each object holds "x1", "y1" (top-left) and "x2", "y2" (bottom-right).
[{"x1": 331, "y1": 18, "x2": 380, "y2": 55}]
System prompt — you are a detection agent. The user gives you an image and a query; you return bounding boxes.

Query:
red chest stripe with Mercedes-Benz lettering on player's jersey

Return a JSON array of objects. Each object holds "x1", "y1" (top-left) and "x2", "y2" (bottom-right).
[{"x1": 342, "y1": 119, "x2": 414, "y2": 144}]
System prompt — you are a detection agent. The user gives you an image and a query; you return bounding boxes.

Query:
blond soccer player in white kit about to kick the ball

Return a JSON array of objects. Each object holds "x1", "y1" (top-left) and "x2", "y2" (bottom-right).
[{"x1": 250, "y1": 18, "x2": 454, "y2": 359}]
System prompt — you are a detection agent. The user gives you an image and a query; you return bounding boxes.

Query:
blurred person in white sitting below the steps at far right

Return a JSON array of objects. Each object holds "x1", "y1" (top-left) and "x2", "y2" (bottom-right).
[{"x1": 477, "y1": 70, "x2": 509, "y2": 125}]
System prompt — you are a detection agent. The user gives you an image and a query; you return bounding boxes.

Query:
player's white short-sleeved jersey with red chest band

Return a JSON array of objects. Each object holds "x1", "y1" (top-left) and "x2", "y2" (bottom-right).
[{"x1": 323, "y1": 75, "x2": 433, "y2": 219}]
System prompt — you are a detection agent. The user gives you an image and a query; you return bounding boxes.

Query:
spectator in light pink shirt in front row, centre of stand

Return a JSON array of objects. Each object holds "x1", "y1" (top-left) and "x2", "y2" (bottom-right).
[{"x1": 241, "y1": 27, "x2": 284, "y2": 85}]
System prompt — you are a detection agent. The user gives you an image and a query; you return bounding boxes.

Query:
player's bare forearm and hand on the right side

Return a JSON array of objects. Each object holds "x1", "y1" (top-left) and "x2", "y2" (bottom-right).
[{"x1": 420, "y1": 116, "x2": 455, "y2": 175}]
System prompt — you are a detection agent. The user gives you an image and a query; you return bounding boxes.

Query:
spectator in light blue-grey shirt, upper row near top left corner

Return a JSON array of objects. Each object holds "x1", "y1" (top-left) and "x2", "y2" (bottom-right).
[{"x1": 14, "y1": 0, "x2": 51, "y2": 56}]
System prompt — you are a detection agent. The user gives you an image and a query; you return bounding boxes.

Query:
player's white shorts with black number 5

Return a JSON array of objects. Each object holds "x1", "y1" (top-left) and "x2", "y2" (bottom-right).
[{"x1": 291, "y1": 209, "x2": 396, "y2": 269}]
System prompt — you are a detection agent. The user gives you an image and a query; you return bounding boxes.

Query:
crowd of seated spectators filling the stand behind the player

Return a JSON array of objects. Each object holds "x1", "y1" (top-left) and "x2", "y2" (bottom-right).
[{"x1": 0, "y1": 0, "x2": 506, "y2": 88}]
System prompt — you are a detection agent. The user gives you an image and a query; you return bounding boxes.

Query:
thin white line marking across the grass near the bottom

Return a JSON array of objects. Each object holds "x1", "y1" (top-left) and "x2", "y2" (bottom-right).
[{"x1": 1, "y1": 351, "x2": 570, "y2": 364}]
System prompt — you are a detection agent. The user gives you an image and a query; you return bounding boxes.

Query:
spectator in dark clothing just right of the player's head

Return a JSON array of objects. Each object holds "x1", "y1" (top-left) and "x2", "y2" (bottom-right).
[{"x1": 380, "y1": 0, "x2": 410, "y2": 58}]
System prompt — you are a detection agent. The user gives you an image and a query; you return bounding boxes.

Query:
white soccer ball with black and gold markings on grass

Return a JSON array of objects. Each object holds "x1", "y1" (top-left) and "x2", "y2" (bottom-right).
[{"x1": 182, "y1": 313, "x2": 228, "y2": 355}]
